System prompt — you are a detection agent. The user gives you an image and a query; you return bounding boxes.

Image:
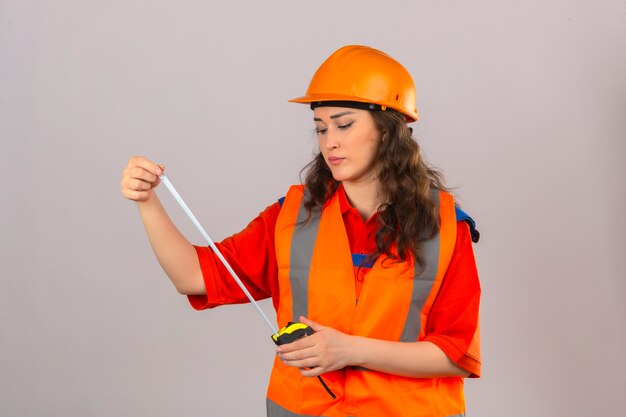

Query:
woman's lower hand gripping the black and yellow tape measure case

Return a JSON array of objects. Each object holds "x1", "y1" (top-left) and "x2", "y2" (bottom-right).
[{"x1": 276, "y1": 316, "x2": 354, "y2": 376}]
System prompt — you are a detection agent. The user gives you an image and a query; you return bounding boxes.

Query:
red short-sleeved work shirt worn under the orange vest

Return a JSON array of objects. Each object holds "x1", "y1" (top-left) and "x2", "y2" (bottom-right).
[{"x1": 188, "y1": 186, "x2": 481, "y2": 377}]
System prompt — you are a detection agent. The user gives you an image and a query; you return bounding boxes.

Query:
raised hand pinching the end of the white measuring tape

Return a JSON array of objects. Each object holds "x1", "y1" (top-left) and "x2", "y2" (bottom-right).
[{"x1": 121, "y1": 156, "x2": 165, "y2": 202}]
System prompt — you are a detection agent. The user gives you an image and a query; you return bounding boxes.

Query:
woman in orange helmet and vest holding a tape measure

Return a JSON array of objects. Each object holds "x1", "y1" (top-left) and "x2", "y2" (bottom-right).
[{"x1": 122, "y1": 45, "x2": 481, "y2": 417}]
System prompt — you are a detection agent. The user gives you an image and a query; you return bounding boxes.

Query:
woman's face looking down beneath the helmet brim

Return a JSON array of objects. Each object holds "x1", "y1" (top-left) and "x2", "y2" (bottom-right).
[{"x1": 313, "y1": 107, "x2": 381, "y2": 184}]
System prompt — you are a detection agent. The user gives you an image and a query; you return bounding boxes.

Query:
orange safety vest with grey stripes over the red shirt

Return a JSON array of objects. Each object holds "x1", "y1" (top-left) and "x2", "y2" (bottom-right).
[{"x1": 267, "y1": 186, "x2": 465, "y2": 417}]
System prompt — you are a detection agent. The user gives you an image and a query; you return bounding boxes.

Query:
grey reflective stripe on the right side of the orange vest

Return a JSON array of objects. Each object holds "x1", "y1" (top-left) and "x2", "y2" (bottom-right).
[{"x1": 400, "y1": 190, "x2": 439, "y2": 342}]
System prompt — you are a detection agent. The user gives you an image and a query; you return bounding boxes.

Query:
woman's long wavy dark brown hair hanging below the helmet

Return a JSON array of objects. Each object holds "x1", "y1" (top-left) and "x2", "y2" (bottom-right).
[{"x1": 302, "y1": 109, "x2": 447, "y2": 266}]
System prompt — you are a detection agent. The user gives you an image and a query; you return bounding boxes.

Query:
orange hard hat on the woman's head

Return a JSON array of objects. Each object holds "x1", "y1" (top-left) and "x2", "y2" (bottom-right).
[{"x1": 289, "y1": 45, "x2": 418, "y2": 123}]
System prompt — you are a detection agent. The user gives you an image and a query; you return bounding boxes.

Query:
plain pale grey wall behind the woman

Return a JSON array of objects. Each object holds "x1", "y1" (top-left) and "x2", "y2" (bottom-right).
[{"x1": 0, "y1": 0, "x2": 626, "y2": 417}]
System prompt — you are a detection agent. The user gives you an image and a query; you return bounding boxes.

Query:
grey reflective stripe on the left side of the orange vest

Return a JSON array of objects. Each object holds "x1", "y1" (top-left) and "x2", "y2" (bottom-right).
[{"x1": 289, "y1": 190, "x2": 321, "y2": 322}]
